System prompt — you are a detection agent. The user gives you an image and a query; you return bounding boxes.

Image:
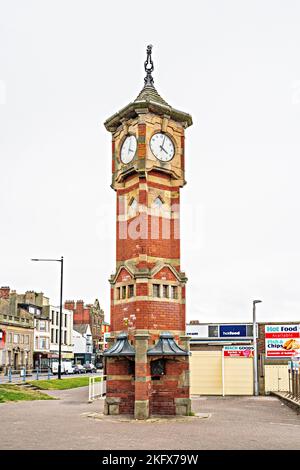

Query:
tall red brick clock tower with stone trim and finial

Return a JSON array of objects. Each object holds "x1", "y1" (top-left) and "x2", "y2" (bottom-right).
[{"x1": 105, "y1": 46, "x2": 192, "y2": 419}]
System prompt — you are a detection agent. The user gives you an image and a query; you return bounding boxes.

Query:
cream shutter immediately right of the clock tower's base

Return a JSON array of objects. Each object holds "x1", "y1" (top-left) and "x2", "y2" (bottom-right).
[{"x1": 190, "y1": 351, "x2": 222, "y2": 395}]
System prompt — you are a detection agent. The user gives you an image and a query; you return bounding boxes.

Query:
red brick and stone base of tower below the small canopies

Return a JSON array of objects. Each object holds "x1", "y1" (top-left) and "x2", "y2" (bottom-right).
[{"x1": 104, "y1": 342, "x2": 191, "y2": 419}]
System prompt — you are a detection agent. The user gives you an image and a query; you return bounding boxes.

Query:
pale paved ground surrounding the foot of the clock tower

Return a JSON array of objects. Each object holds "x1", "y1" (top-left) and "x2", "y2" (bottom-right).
[{"x1": 0, "y1": 387, "x2": 300, "y2": 450}]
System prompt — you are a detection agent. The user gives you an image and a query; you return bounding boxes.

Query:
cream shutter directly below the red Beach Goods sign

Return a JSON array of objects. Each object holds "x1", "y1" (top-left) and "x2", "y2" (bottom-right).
[{"x1": 224, "y1": 357, "x2": 253, "y2": 395}]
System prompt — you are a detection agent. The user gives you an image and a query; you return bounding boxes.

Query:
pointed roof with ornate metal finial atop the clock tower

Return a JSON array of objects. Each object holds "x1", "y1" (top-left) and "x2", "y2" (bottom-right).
[{"x1": 104, "y1": 45, "x2": 192, "y2": 132}]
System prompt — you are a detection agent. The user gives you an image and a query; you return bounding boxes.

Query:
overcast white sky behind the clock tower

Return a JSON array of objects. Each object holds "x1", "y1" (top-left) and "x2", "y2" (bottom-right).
[{"x1": 0, "y1": 0, "x2": 300, "y2": 322}]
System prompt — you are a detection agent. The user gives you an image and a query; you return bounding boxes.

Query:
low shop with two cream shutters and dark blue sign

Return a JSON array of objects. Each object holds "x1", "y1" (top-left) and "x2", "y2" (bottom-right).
[{"x1": 186, "y1": 321, "x2": 253, "y2": 396}]
